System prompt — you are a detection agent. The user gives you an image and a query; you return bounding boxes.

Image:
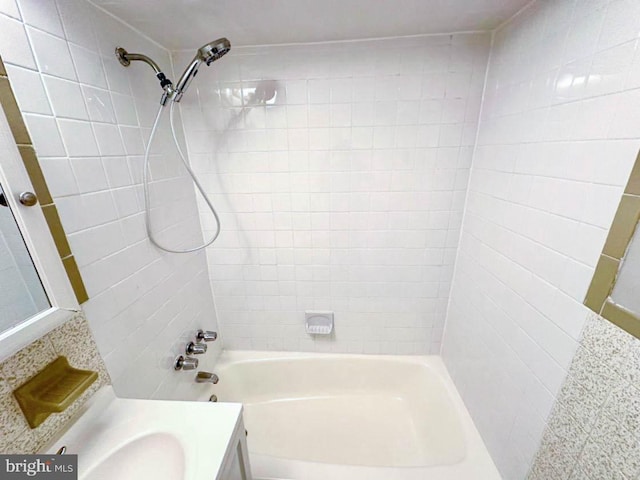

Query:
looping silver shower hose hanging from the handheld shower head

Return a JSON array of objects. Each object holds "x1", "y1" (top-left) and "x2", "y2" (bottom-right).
[{"x1": 142, "y1": 99, "x2": 220, "y2": 253}]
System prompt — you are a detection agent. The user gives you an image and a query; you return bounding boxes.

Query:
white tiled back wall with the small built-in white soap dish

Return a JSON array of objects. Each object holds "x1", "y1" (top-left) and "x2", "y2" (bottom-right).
[{"x1": 174, "y1": 34, "x2": 489, "y2": 354}]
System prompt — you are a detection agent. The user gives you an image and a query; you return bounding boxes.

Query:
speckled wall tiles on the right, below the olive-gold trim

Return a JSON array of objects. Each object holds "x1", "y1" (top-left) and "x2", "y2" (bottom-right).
[{"x1": 528, "y1": 313, "x2": 640, "y2": 480}]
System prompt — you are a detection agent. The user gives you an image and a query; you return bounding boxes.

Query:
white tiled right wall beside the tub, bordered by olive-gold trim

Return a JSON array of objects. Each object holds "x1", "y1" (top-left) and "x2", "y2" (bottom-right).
[{"x1": 442, "y1": 0, "x2": 640, "y2": 480}]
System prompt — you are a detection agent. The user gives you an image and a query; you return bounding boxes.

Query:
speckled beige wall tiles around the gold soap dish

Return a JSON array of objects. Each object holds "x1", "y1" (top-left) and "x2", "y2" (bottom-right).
[{"x1": 0, "y1": 313, "x2": 110, "y2": 454}]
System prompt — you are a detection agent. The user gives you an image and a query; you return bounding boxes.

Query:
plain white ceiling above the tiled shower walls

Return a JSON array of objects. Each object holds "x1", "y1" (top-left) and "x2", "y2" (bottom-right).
[{"x1": 93, "y1": 0, "x2": 530, "y2": 50}]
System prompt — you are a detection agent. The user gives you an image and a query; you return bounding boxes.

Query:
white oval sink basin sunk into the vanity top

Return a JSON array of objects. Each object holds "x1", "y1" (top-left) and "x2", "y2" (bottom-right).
[{"x1": 82, "y1": 433, "x2": 185, "y2": 480}]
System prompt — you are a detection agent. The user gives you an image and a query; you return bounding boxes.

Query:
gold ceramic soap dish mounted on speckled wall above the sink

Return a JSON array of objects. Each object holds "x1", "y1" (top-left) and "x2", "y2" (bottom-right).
[{"x1": 13, "y1": 357, "x2": 98, "y2": 428}]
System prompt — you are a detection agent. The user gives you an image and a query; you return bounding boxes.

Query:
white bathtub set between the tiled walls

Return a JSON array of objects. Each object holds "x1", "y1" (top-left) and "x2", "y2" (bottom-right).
[{"x1": 206, "y1": 351, "x2": 500, "y2": 480}]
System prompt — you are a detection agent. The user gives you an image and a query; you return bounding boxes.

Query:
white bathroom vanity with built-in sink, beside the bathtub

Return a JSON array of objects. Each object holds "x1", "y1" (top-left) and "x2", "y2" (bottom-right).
[{"x1": 46, "y1": 387, "x2": 251, "y2": 480}]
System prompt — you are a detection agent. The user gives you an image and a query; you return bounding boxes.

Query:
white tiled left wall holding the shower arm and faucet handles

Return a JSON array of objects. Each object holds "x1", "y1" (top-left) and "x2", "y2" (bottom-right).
[{"x1": 0, "y1": 0, "x2": 222, "y2": 398}]
